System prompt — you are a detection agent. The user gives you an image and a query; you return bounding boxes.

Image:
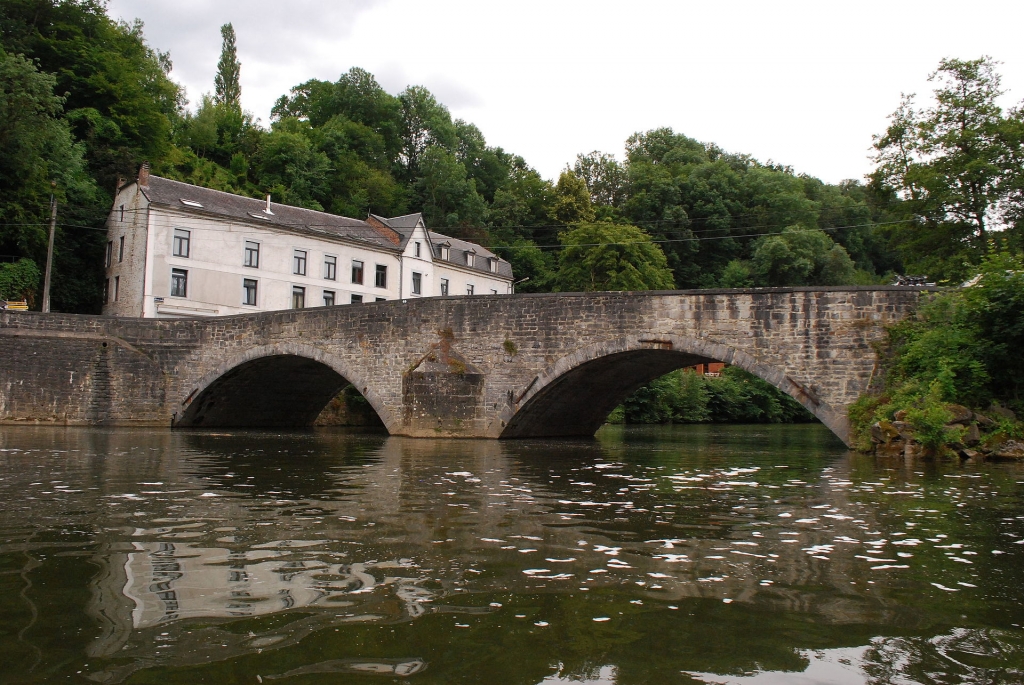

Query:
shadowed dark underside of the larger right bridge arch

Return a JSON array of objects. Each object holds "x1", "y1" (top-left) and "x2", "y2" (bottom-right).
[{"x1": 501, "y1": 349, "x2": 717, "y2": 438}]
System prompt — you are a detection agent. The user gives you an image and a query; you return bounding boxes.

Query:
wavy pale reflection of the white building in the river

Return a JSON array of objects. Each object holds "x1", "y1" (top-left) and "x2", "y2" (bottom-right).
[{"x1": 124, "y1": 541, "x2": 431, "y2": 629}]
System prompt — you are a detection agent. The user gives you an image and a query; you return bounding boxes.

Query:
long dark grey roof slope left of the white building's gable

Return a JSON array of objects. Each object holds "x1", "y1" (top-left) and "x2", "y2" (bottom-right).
[{"x1": 142, "y1": 175, "x2": 399, "y2": 250}]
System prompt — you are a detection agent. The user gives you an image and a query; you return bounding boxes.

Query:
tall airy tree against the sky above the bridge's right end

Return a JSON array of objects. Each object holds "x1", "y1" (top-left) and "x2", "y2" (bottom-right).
[{"x1": 871, "y1": 57, "x2": 1022, "y2": 280}]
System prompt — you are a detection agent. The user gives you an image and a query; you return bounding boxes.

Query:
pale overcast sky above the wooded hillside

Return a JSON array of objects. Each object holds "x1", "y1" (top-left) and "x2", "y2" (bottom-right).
[{"x1": 110, "y1": 0, "x2": 1024, "y2": 182}]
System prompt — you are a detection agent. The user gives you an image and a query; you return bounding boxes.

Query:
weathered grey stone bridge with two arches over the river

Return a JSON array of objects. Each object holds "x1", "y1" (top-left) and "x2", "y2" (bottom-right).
[{"x1": 0, "y1": 287, "x2": 923, "y2": 441}]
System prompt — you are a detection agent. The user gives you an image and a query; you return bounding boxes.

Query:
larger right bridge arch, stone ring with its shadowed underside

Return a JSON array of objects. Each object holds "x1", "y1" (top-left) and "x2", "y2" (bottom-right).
[{"x1": 500, "y1": 335, "x2": 849, "y2": 444}]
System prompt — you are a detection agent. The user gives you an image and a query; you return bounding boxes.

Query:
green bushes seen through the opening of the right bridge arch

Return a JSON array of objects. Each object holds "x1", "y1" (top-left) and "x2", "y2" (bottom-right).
[{"x1": 608, "y1": 367, "x2": 815, "y2": 424}]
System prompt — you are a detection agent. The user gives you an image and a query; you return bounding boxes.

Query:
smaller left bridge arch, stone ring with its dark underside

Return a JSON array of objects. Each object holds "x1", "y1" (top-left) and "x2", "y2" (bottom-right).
[{"x1": 174, "y1": 342, "x2": 398, "y2": 432}]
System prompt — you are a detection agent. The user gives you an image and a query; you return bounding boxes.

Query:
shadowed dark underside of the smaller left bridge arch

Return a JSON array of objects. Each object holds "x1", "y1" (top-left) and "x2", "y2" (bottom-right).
[{"x1": 175, "y1": 354, "x2": 346, "y2": 428}]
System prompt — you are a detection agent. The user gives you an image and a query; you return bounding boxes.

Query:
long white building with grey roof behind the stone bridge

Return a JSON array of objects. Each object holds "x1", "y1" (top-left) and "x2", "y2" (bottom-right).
[{"x1": 103, "y1": 166, "x2": 512, "y2": 317}]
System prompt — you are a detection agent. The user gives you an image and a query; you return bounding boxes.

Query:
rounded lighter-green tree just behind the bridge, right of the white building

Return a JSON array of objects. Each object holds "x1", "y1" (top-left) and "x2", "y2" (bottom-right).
[{"x1": 553, "y1": 222, "x2": 673, "y2": 292}]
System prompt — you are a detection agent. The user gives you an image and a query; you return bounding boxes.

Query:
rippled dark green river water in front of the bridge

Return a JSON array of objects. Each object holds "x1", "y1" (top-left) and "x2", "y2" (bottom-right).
[{"x1": 0, "y1": 426, "x2": 1024, "y2": 685}]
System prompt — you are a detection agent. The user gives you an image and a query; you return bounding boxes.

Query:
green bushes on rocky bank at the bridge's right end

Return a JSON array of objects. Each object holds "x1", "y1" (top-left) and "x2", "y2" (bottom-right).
[{"x1": 850, "y1": 252, "x2": 1024, "y2": 457}]
